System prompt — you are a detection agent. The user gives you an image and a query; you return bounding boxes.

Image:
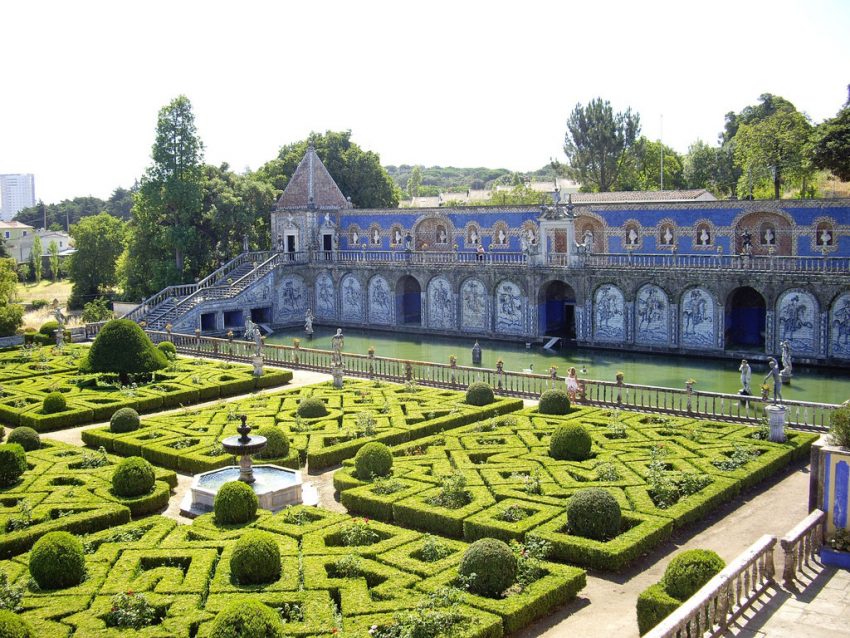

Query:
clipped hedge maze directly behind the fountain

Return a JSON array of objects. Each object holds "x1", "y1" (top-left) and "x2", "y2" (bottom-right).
[{"x1": 82, "y1": 380, "x2": 522, "y2": 474}]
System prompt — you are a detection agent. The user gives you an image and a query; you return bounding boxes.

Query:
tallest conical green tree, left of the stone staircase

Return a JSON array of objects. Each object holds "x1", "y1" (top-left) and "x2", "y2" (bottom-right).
[{"x1": 128, "y1": 95, "x2": 204, "y2": 292}]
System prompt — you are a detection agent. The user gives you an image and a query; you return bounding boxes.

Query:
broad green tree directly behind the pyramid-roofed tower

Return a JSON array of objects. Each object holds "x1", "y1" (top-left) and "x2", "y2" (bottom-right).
[{"x1": 257, "y1": 131, "x2": 399, "y2": 208}]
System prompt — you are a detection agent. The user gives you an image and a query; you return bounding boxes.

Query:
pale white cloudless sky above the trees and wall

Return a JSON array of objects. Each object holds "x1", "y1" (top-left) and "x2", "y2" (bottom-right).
[{"x1": 0, "y1": 0, "x2": 850, "y2": 202}]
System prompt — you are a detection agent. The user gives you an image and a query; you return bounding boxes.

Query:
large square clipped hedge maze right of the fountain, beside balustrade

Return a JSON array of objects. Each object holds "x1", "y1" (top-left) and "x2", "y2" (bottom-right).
[{"x1": 334, "y1": 408, "x2": 817, "y2": 570}]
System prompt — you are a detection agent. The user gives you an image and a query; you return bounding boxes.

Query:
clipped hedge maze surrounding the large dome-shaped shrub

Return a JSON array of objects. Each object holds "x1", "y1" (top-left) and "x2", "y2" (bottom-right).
[{"x1": 0, "y1": 346, "x2": 292, "y2": 432}]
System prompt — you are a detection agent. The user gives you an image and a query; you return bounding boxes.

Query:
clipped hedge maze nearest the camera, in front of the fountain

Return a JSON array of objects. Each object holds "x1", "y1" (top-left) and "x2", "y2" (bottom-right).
[{"x1": 0, "y1": 506, "x2": 585, "y2": 638}]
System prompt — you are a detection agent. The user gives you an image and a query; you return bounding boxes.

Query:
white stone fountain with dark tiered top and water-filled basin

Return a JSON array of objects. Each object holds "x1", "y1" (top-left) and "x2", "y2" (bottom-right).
[{"x1": 180, "y1": 414, "x2": 318, "y2": 517}]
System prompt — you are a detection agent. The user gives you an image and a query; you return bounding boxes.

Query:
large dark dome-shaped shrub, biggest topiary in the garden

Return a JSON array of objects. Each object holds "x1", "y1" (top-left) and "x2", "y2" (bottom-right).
[{"x1": 81, "y1": 319, "x2": 168, "y2": 385}]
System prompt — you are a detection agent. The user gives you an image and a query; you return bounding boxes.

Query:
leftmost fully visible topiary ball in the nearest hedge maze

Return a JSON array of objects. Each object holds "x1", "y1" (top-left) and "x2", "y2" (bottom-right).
[{"x1": 29, "y1": 532, "x2": 86, "y2": 589}]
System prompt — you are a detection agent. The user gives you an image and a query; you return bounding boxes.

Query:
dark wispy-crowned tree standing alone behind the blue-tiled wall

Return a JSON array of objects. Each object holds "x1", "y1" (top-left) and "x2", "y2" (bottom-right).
[{"x1": 564, "y1": 98, "x2": 640, "y2": 192}]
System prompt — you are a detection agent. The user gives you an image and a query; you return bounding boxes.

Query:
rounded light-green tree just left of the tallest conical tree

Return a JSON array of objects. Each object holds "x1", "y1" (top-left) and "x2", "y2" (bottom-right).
[{"x1": 68, "y1": 213, "x2": 125, "y2": 308}]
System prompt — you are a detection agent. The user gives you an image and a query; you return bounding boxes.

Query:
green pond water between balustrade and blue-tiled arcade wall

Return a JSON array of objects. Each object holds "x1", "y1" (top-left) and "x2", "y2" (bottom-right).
[{"x1": 266, "y1": 327, "x2": 850, "y2": 403}]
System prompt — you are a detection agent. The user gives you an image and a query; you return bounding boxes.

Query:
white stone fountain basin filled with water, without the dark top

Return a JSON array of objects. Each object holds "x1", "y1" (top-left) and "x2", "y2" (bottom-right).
[{"x1": 180, "y1": 465, "x2": 302, "y2": 516}]
